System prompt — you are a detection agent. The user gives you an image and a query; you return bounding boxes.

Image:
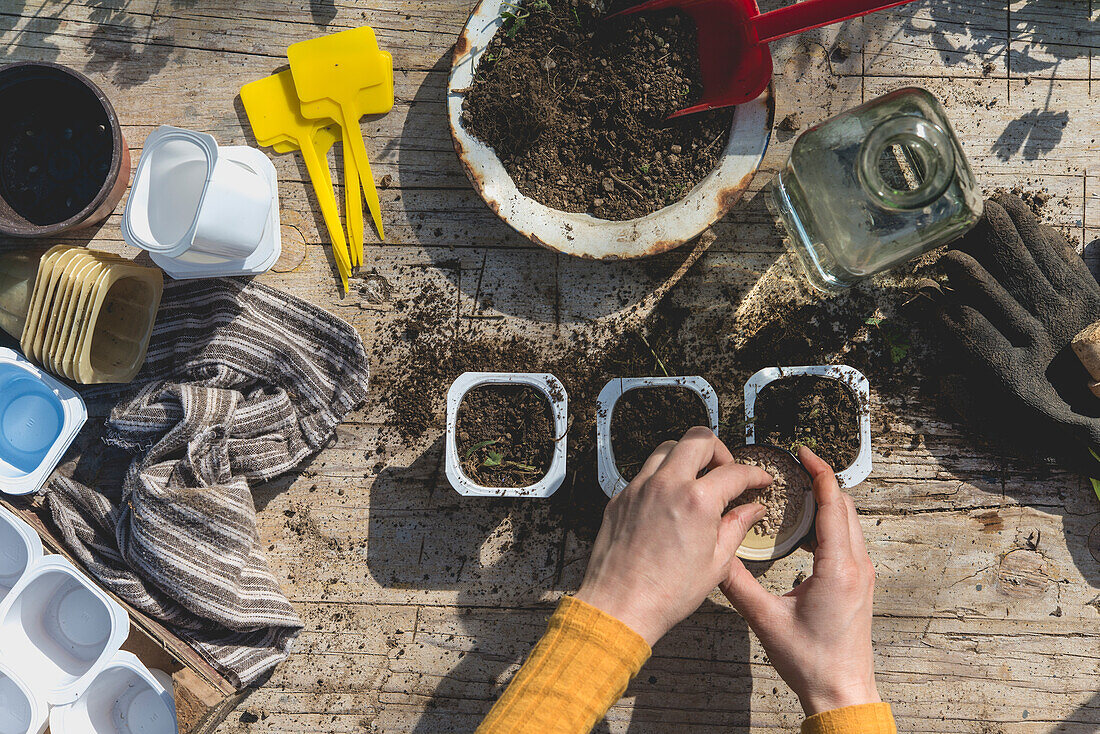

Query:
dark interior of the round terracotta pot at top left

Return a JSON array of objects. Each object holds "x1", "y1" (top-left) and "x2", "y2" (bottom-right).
[{"x1": 0, "y1": 69, "x2": 114, "y2": 232}]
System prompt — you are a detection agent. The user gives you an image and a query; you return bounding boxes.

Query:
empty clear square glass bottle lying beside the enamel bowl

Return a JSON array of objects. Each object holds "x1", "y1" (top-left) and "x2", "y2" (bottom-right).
[{"x1": 768, "y1": 87, "x2": 982, "y2": 291}]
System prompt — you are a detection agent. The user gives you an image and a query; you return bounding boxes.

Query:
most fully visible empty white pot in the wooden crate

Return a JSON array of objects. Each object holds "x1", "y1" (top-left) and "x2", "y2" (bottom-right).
[{"x1": 0, "y1": 556, "x2": 130, "y2": 705}]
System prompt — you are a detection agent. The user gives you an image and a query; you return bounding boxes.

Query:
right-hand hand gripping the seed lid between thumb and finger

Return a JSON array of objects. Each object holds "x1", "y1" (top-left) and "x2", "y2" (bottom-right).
[{"x1": 722, "y1": 448, "x2": 880, "y2": 716}]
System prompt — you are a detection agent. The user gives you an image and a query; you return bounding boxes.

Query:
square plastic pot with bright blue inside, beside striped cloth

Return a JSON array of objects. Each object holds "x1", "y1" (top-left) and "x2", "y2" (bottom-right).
[{"x1": 0, "y1": 349, "x2": 88, "y2": 494}]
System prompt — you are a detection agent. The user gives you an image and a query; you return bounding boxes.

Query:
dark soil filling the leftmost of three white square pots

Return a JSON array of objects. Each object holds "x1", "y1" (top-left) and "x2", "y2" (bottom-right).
[{"x1": 455, "y1": 385, "x2": 554, "y2": 487}]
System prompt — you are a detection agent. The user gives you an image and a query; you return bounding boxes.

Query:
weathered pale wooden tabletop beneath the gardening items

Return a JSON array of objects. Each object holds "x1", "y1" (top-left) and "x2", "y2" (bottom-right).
[{"x1": 0, "y1": 0, "x2": 1100, "y2": 734}]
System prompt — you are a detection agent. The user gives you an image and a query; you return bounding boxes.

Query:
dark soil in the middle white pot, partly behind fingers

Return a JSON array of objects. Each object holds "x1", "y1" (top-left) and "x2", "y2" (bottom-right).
[{"x1": 612, "y1": 387, "x2": 710, "y2": 482}]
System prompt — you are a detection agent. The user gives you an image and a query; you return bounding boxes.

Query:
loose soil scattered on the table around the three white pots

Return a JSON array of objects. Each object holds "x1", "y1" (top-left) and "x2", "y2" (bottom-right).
[{"x1": 365, "y1": 244, "x2": 938, "y2": 541}]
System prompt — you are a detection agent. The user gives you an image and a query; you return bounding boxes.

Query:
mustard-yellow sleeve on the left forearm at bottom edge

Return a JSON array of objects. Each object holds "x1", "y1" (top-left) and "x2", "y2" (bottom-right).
[{"x1": 477, "y1": 596, "x2": 651, "y2": 734}]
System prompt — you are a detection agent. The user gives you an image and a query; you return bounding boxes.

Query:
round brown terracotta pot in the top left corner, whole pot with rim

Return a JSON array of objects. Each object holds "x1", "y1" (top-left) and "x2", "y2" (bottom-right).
[{"x1": 0, "y1": 62, "x2": 130, "y2": 237}]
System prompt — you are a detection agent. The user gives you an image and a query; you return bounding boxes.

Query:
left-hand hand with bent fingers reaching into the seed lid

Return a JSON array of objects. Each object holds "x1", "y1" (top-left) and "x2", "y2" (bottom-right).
[{"x1": 576, "y1": 427, "x2": 771, "y2": 647}]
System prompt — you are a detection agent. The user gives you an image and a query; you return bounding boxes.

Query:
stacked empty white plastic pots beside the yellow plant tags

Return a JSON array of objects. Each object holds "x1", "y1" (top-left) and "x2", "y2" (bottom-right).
[{"x1": 122, "y1": 125, "x2": 282, "y2": 280}]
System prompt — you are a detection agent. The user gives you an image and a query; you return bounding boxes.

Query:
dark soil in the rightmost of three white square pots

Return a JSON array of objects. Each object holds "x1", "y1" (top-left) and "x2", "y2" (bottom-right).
[{"x1": 755, "y1": 375, "x2": 867, "y2": 471}]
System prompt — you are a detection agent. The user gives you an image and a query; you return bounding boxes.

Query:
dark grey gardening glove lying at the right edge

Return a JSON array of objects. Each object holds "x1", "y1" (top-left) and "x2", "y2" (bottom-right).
[{"x1": 938, "y1": 195, "x2": 1100, "y2": 476}]
